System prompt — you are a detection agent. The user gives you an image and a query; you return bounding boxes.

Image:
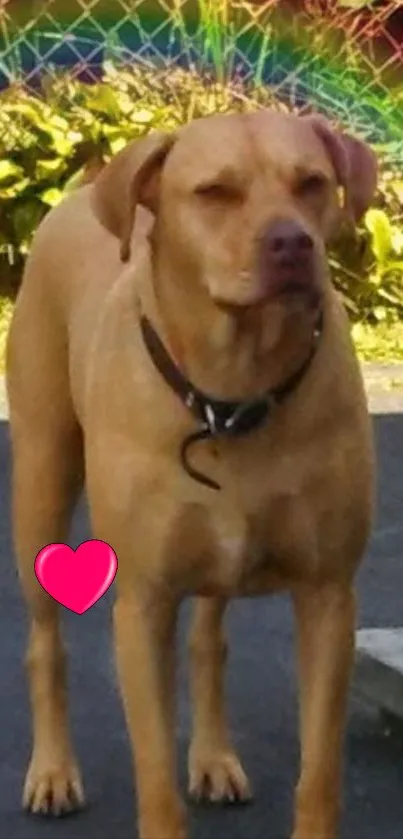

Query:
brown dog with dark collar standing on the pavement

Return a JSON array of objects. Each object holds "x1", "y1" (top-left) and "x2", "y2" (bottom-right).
[{"x1": 8, "y1": 111, "x2": 377, "y2": 839}]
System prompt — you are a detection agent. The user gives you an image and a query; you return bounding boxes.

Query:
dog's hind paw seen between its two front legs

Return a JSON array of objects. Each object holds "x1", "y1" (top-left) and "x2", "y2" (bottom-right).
[{"x1": 189, "y1": 750, "x2": 252, "y2": 804}]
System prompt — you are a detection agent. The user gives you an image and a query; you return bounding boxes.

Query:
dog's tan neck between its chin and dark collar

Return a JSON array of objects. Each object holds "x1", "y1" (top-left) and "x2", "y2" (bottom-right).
[{"x1": 137, "y1": 253, "x2": 326, "y2": 399}]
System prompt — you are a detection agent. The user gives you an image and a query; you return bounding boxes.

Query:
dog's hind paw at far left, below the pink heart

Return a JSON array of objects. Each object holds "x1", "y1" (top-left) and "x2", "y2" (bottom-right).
[{"x1": 23, "y1": 758, "x2": 85, "y2": 816}]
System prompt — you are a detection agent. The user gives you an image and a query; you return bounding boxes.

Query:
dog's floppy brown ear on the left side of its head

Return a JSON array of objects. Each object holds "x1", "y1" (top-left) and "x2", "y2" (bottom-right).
[{"x1": 92, "y1": 132, "x2": 176, "y2": 262}]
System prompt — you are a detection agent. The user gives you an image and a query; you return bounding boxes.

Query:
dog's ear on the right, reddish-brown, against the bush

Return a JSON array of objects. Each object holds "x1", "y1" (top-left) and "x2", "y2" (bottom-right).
[{"x1": 303, "y1": 116, "x2": 378, "y2": 223}]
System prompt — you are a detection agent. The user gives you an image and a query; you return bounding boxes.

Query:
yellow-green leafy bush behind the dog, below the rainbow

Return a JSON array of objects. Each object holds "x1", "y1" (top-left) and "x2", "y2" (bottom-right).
[{"x1": 0, "y1": 63, "x2": 403, "y2": 323}]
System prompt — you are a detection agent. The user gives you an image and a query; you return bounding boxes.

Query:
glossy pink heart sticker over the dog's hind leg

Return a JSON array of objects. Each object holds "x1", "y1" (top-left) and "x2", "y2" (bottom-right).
[{"x1": 35, "y1": 539, "x2": 118, "y2": 615}]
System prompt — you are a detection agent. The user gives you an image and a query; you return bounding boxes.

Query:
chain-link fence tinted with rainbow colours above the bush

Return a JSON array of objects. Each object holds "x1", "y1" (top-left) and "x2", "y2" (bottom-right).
[{"x1": 0, "y1": 0, "x2": 403, "y2": 154}]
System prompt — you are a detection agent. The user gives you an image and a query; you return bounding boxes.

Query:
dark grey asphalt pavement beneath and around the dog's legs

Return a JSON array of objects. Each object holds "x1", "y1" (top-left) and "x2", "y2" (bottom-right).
[{"x1": 0, "y1": 368, "x2": 403, "y2": 839}]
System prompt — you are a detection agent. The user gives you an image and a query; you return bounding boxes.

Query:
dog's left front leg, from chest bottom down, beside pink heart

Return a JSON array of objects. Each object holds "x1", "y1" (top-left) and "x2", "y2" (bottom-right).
[{"x1": 114, "y1": 587, "x2": 186, "y2": 839}]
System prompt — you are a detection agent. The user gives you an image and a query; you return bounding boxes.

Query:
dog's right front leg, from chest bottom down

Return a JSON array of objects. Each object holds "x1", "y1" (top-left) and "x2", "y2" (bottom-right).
[{"x1": 293, "y1": 584, "x2": 355, "y2": 839}]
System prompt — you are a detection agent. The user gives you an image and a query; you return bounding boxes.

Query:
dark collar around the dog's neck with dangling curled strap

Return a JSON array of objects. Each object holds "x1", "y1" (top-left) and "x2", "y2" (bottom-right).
[{"x1": 140, "y1": 311, "x2": 323, "y2": 490}]
